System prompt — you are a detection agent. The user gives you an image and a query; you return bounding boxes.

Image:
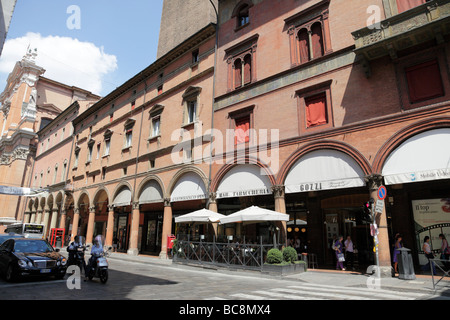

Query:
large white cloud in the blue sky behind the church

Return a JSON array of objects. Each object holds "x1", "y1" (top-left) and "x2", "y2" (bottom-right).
[{"x1": 0, "y1": 32, "x2": 117, "y2": 95}]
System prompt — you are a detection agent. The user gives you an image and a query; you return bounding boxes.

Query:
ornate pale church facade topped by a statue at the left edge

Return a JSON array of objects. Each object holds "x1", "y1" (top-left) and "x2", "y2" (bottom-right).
[{"x1": 0, "y1": 50, "x2": 99, "y2": 230}]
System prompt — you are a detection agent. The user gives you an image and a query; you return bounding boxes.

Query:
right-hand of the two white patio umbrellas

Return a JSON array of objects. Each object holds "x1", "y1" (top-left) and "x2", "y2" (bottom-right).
[{"x1": 220, "y1": 206, "x2": 289, "y2": 224}]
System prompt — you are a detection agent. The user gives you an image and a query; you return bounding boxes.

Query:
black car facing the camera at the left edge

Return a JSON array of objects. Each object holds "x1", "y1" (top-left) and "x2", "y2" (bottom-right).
[{"x1": 0, "y1": 238, "x2": 67, "y2": 281}]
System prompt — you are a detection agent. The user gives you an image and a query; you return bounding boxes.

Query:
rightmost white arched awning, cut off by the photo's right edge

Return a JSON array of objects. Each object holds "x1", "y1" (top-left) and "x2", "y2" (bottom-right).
[{"x1": 382, "y1": 128, "x2": 450, "y2": 185}]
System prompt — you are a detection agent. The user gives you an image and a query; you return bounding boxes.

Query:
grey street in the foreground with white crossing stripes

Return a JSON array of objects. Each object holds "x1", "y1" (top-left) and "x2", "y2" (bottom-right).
[{"x1": 0, "y1": 255, "x2": 448, "y2": 302}]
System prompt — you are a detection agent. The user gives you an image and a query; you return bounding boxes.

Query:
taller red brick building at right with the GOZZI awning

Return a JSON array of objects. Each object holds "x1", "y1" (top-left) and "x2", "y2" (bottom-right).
[{"x1": 210, "y1": 0, "x2": 450, "y2": 273}]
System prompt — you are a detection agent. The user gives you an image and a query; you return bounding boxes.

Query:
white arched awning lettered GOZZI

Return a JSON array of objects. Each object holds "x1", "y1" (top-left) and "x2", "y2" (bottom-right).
[{"x1": 284, "y1": 149, "x2": 365, "y2": 193}]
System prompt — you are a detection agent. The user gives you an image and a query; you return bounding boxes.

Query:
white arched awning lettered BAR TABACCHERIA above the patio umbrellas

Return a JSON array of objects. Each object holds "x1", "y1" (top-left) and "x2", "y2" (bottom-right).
[{"x1": 216, "y1": 164, "x2": 272, "y2": 199}]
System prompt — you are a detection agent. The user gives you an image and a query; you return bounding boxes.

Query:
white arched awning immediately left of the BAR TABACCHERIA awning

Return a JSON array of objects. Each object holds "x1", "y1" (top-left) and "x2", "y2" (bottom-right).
[{"x1": 170, "y1": 172, "x2": 207, "y2": 202}]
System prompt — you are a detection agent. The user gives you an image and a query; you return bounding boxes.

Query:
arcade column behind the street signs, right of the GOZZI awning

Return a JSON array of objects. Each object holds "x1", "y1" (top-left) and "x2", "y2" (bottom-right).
[{"x1": 365, "y1": 174, "x2": 392, "y2": 278}]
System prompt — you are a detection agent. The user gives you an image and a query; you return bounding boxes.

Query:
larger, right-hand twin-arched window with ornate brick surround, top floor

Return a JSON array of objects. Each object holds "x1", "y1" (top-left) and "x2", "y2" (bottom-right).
[{"x1": 285, "y1": 0, "x2": 332, "y2": 66}]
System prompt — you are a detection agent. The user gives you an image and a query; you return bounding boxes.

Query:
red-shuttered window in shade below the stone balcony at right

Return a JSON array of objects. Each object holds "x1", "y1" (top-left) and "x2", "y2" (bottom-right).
[{"x1": 405, "y1": 60, "x2": 444, "y2": 103}]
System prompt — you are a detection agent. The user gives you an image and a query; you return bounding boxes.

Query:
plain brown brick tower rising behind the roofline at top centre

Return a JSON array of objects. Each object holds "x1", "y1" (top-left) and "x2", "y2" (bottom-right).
[{"x1": 157, "y1": 0, "x2": 218, "y2": 59}]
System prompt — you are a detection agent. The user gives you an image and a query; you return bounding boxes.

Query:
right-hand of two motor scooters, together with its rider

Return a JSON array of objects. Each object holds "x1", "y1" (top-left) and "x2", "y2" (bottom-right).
[{"x1": 86, "y1": 236, "x2": 112, "y2": 283}]
